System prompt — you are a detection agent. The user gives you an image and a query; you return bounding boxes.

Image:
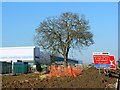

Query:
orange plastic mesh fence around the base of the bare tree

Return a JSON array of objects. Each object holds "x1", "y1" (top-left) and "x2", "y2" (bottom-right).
[{"x1": 49, "y1": 66, "x2": 81, "y2": 77}]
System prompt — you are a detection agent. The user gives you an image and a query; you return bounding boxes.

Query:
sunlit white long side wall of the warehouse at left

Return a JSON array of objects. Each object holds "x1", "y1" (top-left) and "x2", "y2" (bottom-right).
[{"x1": 0, "y1": 46, "x2": 35, "y2": 61}]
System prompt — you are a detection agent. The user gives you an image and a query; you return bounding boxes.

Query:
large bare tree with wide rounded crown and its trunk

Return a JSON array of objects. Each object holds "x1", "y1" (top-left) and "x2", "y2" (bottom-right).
[{"x1": 34, "y1": 12, "x2": 94, "y2": 66}]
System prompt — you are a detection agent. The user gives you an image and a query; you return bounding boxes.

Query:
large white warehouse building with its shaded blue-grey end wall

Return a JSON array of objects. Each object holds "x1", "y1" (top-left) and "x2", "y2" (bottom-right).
[{"x1": 0, "y1": 46, "x2": 43, "y2": 65}]
